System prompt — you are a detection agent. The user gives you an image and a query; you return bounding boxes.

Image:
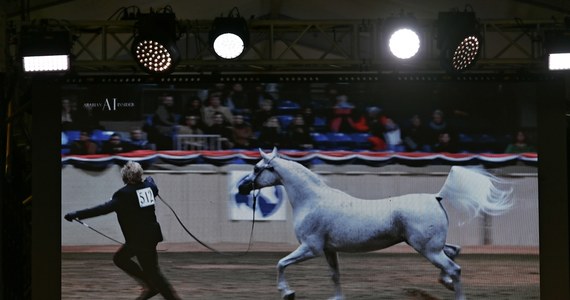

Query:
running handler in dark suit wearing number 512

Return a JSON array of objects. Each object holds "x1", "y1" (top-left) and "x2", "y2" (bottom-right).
[{"x1": 65, "y1": 161, "x2": 180, "y2": 299}]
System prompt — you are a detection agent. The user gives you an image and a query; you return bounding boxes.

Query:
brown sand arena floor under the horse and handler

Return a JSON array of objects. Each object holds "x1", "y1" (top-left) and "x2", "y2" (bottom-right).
[{"x1": 61, "y1": 246, "x2": 540, "y2": 300}]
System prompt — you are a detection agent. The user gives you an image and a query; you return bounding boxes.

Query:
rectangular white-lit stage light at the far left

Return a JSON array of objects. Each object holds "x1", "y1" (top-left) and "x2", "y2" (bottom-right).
[{"x1": 20, "y1": 27, "x2": 72, "y2": 72}]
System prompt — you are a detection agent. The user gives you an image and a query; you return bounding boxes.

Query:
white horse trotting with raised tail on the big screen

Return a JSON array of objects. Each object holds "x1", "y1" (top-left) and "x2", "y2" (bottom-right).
[{"x1": 239, "y1": 148, "x2": 512, "y2": 300}]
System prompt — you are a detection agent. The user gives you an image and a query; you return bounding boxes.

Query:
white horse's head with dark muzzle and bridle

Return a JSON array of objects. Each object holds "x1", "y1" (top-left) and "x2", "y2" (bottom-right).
[{"x1": 238, "y1": 148, "x2": 281, "y2": 195}]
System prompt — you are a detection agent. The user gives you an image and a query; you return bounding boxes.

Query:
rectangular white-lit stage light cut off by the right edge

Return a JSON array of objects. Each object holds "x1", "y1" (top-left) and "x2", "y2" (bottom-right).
[{"x1": 544, "y1": 30, "x2": 570, "y2": 71}]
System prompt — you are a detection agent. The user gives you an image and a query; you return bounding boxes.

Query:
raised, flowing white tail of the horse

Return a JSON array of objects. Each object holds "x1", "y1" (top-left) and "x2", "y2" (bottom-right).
[{"x1": 438, "y1": 166, "x2": 513, "y2": 217}]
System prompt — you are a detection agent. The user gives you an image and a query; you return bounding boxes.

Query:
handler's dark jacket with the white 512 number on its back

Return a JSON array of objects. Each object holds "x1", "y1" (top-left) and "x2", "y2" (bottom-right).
[{"x1": 74, "y1": 178, "x2": 163, "y2": 246}]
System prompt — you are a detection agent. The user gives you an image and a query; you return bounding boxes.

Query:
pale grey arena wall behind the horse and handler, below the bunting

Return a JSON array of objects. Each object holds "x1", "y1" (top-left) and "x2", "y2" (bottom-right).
[{"x1": 61, "y1": 164, "x2": 539, "y2": 247}]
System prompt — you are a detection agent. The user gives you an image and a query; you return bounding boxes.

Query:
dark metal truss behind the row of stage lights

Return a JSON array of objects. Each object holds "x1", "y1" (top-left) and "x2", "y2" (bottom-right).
[{"x1": 5, "y1": 19, "x2": 562, "y2": 74}]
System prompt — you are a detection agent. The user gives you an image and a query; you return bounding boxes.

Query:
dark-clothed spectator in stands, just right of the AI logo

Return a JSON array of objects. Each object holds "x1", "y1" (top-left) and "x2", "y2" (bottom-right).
[{"x1": 149, "y1": 95, "x2": 178, "y2": 150}]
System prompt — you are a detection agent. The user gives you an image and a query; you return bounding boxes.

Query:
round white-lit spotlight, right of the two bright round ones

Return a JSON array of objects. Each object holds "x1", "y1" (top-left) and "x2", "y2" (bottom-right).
[{"x1": 383, "y1": 15, "x2": 421, "y2": 60}]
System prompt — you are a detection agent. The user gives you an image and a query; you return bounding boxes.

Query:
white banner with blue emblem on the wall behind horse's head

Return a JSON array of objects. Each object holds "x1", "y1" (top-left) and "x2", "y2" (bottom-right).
[{"x1": 228, "y1": 171, "x2": 288, "y2": 221}]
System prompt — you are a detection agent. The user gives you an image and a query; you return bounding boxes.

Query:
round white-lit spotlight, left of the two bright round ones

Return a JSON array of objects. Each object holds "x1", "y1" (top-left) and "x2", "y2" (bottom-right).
[{"x1": 209, "y1": 7, "x2": 249, "y2": 59}]
